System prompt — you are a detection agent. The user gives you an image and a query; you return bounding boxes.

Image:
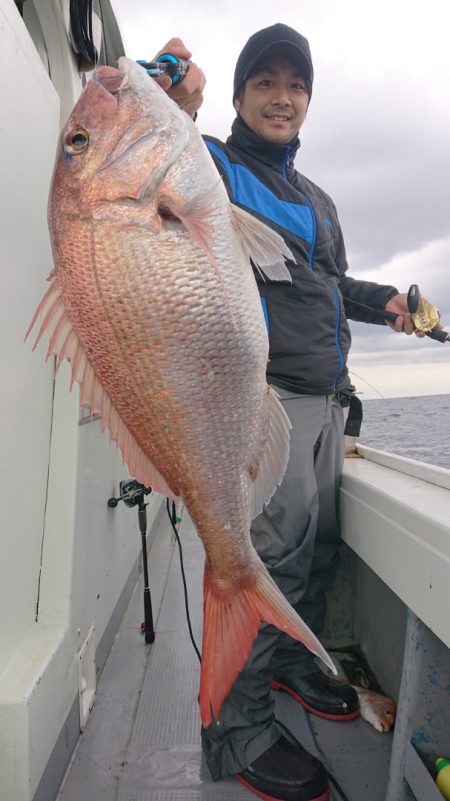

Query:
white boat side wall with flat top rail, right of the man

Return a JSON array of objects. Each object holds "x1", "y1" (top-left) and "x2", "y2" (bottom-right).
[{"x1": 326, "y1": 445, "x2": 450, "y2": 801}]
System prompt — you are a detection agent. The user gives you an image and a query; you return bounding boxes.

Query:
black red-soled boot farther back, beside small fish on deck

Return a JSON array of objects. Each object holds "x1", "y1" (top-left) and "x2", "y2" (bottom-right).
[{"x1": 272, "y1": 670, "x2": 359, "y2": 720}]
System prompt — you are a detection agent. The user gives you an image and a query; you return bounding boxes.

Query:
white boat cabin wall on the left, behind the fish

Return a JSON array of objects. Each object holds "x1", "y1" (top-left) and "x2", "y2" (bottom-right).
[{"x1": 0, "y1": 0, "x2": 166, "y2": 801}]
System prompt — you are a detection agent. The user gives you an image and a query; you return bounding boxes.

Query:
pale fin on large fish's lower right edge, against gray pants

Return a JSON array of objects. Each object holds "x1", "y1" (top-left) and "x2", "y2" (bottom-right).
[{"x1": 249, "y1": 386, "x2": 291, "y2": 518}]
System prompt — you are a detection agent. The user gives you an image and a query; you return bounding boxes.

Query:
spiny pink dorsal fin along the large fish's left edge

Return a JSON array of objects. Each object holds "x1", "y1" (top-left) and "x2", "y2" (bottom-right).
[{"x1": 25, "y1": 274, "x2": 178, "y2": 500}]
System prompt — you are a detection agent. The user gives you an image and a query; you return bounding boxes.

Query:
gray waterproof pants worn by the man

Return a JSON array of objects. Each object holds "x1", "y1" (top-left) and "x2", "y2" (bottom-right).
[{"x1": 202, "y1": 387, "x2": 344, "y2": 780}]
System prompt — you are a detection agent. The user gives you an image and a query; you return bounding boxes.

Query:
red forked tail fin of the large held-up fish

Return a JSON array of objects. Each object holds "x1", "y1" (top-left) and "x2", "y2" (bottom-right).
[{"x1": 200, "y1": 562, "x2": 336, "y2": 726}]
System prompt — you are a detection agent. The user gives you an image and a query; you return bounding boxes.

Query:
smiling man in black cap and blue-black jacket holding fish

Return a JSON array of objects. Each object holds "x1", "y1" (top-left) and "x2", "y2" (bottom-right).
[{"x1": 155, "y1": 24, "x2": 436, "y2": 801}]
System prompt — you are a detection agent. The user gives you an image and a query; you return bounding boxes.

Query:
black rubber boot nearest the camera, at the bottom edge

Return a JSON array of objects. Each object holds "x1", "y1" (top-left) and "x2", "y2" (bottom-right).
[{"x1": 236, "y1": 735, "x2": 330, "y2": 801}]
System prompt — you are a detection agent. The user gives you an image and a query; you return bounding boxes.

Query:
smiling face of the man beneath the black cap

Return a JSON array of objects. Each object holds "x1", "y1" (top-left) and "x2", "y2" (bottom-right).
[{"x1": 234, "y1": 57, "x2": 309, "y2": 145}]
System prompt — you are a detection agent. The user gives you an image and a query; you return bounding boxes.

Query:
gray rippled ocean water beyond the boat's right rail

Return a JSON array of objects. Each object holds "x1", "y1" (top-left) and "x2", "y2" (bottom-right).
[{"x1": 358, "y1": 395, "x2": 450, "y2": 469}]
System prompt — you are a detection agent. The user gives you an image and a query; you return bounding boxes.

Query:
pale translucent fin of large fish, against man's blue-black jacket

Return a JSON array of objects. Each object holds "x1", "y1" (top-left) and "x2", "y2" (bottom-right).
[{"x1": 231, "y1": 203, "x2": 295, "y2": 284}]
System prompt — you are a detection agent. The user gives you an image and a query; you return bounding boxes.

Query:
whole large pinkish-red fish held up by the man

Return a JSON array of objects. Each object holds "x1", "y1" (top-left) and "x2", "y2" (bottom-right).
[{"x1": 27, "y1": 59, "x2": 333, "y2": 725}]
